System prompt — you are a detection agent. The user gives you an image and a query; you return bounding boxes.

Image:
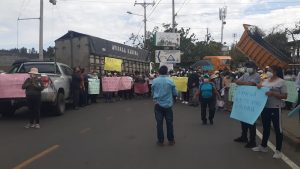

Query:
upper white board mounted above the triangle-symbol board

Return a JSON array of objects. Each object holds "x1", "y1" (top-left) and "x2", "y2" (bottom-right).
[{"x1": 155, "y1": 32, "x2": 180, "y2": 47}]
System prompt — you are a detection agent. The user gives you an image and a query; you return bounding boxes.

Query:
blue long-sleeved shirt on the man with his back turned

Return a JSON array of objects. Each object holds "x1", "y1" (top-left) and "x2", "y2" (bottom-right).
[{"x1": 151, "y1": 75, "x2": 177, "y2": 108}]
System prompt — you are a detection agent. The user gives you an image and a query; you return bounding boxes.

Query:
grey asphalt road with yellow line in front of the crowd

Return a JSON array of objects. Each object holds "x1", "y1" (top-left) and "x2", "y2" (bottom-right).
[{"x1": 0, "y1": 100, "x2": 299, "y2": 169}]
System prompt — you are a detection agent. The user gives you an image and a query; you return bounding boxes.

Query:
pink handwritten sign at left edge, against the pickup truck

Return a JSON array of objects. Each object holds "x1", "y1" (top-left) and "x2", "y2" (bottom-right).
[{"x1": 0, "y1": 73, "x2": 29, "y2": 99}]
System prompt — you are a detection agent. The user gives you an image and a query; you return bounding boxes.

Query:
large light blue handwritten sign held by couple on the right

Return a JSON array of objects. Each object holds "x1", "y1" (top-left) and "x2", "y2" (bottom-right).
[{"x1": 230, "y1": 86, "x2": 269, "y2": 124}]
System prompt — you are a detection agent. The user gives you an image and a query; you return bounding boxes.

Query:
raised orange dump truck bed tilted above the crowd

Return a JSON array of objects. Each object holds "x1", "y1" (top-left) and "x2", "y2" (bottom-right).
[{"x1": 237, "y1": 24, "x2": 292, "y2": 69}]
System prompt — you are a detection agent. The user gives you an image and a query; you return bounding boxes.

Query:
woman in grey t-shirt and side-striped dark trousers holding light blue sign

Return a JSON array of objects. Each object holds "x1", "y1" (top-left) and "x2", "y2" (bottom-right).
[{"x1": 252, "y1": 66, "x2": 287, "y2": 158}]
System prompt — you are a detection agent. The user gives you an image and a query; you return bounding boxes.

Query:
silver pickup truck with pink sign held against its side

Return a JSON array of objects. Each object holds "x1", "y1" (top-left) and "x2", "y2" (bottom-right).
[{"x1": 0, "y1": 61, "x2": 73, "y2": 116}]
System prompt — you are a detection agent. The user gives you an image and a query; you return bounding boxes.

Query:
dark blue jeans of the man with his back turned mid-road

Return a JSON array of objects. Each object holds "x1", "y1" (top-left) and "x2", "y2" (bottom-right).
[{"x1": 154, "y1": 104, "x2": 174, "y2": 142}]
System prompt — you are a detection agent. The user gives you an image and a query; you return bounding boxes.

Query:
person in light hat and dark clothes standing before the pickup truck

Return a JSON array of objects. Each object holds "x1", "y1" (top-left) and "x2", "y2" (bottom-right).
[{"x1": 22, "y1": 68, "x2": 44, "y2": 129}]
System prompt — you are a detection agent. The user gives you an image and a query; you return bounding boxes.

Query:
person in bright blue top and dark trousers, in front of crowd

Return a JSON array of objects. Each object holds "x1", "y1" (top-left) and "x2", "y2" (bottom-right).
[{"x1": 194, "y1": 75, "x2": 220, "y2": 125}]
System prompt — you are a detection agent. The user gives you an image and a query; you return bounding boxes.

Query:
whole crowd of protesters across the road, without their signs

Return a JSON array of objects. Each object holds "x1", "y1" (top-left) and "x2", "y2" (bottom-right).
[{"x1": 23, "y1": 62, "x2": 300, "y2": 158}]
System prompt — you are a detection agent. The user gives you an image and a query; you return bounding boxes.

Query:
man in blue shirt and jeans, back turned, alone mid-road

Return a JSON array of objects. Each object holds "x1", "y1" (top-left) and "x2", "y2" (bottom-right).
[{"x1": 151, "y1": 66, "x2": 177, "y2": 146}]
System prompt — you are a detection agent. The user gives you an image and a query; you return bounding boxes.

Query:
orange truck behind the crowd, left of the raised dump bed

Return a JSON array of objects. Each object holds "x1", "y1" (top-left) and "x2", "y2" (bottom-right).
[{"x1": 203, "y1": 56, "x2": 231, "y2": 70}]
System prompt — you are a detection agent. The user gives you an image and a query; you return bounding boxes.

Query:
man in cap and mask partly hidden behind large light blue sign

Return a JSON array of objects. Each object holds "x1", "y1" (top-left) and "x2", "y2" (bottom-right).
[{"x1": 234, "y1": 62, "x2": 260, "y2": 148}]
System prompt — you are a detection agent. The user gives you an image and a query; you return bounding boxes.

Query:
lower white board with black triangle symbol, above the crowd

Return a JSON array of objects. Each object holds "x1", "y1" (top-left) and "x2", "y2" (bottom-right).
[{"x1": 155, "y1": 50, "x2": 180, "y2": 63}]
